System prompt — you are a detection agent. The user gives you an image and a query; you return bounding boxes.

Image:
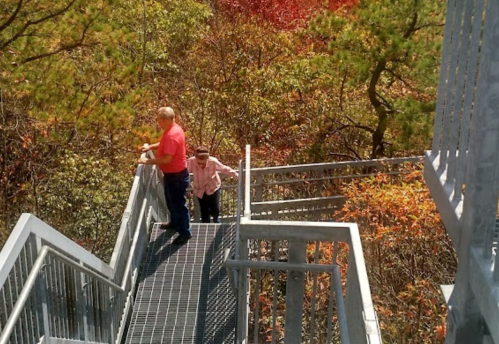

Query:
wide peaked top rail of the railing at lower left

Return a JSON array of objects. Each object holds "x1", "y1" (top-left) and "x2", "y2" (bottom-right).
[{"x1": 0, "y1": 213, "x2": 113, "y2": 286}]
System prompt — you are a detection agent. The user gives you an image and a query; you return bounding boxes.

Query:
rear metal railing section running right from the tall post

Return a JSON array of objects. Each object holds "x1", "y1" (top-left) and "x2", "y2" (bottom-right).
[{"x1": 248, "y1": 157, "x2": 422, "y2": 221}]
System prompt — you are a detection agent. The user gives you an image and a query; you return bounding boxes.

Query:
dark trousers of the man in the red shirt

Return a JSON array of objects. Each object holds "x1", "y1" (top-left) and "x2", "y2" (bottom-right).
[{"x1": 163, "y1": 169, "x2": 191, "y2": 237}]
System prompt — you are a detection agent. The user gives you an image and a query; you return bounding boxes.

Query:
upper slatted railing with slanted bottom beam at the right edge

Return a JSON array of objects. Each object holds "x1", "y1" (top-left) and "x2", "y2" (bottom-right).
[{"x1": 425, "y1": 0, "x2": 492, "y2": 249}]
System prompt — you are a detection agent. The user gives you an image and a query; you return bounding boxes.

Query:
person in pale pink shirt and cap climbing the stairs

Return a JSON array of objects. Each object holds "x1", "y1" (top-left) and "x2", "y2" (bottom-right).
[{"x1": 187, "y1": 146, "x2": 238, "y2": 223}]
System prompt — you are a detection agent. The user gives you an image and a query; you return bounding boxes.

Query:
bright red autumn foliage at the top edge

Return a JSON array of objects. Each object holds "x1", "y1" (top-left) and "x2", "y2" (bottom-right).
[{"x1": 219, "y1": 0, "x2": 358, "y2": 29}]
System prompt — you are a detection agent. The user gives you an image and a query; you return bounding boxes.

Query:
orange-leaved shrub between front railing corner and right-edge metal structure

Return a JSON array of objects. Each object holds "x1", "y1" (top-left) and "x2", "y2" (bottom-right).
[{"x1": 338, "y1": 165, "x2": 457, "y2": 344}]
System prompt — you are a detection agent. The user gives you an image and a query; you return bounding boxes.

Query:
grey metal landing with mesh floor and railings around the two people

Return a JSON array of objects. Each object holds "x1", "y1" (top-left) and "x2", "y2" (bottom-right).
[{"x1": 0, "y1": 147, "x2": 402, "y2": 344}]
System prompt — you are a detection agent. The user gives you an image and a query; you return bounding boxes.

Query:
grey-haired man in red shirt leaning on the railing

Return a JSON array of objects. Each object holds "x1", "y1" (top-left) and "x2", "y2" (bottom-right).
[{"x1": 138, "y1": 107, "x2": 192, "y2": 245}]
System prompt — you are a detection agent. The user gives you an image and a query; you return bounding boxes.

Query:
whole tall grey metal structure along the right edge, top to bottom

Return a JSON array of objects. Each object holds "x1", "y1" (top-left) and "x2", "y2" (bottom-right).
[{"x1": 425, "y1": 0, "x2": 499, "y2": 343}]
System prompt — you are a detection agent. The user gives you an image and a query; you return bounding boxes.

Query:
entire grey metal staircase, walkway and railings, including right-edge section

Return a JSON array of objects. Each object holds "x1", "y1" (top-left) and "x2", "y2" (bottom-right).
[{"x1": 0, "y1": 0, "x2": 499, "y2": 344}]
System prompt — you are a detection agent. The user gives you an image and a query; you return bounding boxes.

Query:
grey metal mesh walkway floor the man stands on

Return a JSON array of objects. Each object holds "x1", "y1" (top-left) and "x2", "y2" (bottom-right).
[{"x1": 126, "y1": 224, "x2": 236, "y2": 344}]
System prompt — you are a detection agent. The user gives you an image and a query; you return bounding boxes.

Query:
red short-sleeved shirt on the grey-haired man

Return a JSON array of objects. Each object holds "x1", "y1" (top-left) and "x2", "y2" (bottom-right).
[{"x1": 157, "y1": 123, "x2": 187, "y2": 173}]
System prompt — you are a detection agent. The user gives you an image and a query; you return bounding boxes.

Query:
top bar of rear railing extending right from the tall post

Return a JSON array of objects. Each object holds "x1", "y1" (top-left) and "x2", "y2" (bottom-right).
[{"x1": 251, "y1": 156, "x2": 423, "y2": 175}]
